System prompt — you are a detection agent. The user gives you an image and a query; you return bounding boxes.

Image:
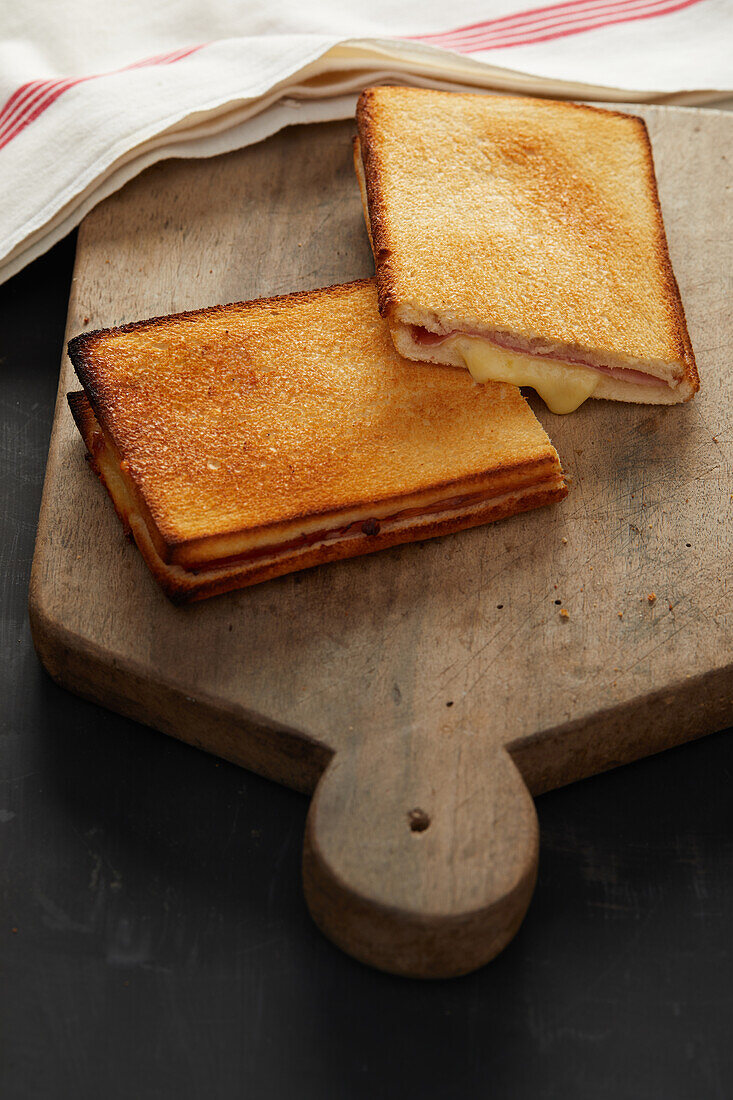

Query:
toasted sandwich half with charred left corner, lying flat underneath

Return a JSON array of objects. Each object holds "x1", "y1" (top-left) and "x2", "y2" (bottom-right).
[{"x1": 69, "y1": 281, "x2": 567, "y2": 600}]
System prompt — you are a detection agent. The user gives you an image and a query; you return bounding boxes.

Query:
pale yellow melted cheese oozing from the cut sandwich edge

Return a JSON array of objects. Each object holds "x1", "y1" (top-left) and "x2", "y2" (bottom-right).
[{"x1": 455, "y1": 337, "x2": 600, "y2": 413}]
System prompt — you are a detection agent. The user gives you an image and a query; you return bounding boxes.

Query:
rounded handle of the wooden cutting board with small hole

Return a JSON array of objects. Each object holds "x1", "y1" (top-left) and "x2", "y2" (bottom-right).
[{"x1": 303, "y1": 725, "x2": 539, "y2": 978}]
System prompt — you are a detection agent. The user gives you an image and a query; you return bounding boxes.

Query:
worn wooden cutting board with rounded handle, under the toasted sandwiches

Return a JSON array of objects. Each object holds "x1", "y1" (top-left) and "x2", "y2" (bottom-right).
[{"x1": 30, "y1": 107, "x2": 733, "y2": 977}]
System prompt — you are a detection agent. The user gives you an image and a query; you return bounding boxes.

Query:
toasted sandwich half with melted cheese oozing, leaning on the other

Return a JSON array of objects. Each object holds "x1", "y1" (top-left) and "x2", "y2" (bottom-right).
[{"x1": 354, "y1": 88, "x2": 699, "y2": 411}]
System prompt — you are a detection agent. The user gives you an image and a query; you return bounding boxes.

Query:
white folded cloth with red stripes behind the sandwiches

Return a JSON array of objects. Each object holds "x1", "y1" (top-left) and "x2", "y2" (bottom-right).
[{"x1": 0, "y1": 0, "x2": 733, "y2": 282}]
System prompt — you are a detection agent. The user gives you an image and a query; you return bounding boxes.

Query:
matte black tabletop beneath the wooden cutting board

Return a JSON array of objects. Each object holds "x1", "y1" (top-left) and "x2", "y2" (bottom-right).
[{"x1": 0, "y1": 239, "x2": 733, "y2": 1100}]
